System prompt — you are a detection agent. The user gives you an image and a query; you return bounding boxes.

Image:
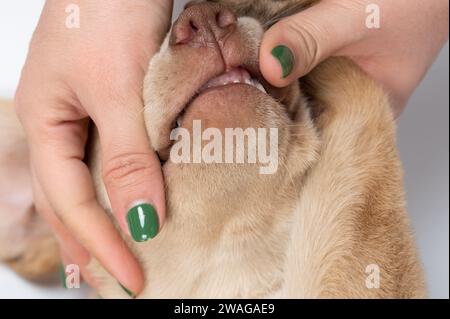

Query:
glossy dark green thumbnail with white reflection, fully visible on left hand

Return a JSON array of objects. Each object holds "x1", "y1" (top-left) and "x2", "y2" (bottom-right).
[{"x1": 127, "y1": 204, "x2": 159, "y2": 243}]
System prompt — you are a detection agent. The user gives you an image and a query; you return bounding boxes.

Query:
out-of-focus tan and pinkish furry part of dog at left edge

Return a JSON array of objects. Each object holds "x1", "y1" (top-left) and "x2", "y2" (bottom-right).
[{"x1": 0, "y1": 100, "x2": 59, "y2": 280}]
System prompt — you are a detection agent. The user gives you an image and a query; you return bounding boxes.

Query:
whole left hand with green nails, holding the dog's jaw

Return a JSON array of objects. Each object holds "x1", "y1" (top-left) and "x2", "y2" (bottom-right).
[{"x1": 16, "y1": 0, "x2": 172, "y2": 294}]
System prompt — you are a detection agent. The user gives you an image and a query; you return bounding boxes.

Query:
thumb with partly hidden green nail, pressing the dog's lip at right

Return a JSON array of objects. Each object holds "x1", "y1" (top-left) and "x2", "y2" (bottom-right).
[{"x1": 260, "y1": 1, "x2": 366, "y2": 87}]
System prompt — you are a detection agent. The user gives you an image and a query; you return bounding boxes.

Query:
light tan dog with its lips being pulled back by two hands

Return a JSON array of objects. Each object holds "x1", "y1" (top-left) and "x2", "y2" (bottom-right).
[{"x1": 1, "y1": 0, "x2": 425, "y2": 298}]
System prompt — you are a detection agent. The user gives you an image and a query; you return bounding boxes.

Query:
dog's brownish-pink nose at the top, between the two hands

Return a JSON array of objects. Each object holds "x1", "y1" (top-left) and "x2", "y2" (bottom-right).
[{"x1": 170, "y1": 3, "x2": 237, "y2": 46}]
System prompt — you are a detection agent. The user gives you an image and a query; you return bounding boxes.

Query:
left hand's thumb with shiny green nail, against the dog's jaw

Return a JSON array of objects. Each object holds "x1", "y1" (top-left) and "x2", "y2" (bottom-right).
[{"x1": 93, "y1": 95, "x2": 165, "y2": 242}]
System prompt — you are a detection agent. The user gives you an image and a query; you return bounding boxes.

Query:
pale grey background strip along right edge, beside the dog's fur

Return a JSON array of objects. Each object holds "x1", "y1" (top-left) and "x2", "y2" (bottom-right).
[{"x1": 398, "y1": 44, "x2": 449, "y2": 298}]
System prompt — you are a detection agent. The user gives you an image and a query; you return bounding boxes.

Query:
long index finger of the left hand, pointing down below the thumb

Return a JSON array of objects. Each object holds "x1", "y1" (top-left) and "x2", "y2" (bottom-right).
[{"x1": 28, "y1": 122, "x2": 144, "y2": 294}]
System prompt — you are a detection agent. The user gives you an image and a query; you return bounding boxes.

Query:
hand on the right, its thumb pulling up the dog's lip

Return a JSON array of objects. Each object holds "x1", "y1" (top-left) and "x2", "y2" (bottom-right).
[{"x1": 260, "y1": 0, "x2": 449, "y2": 115}]
